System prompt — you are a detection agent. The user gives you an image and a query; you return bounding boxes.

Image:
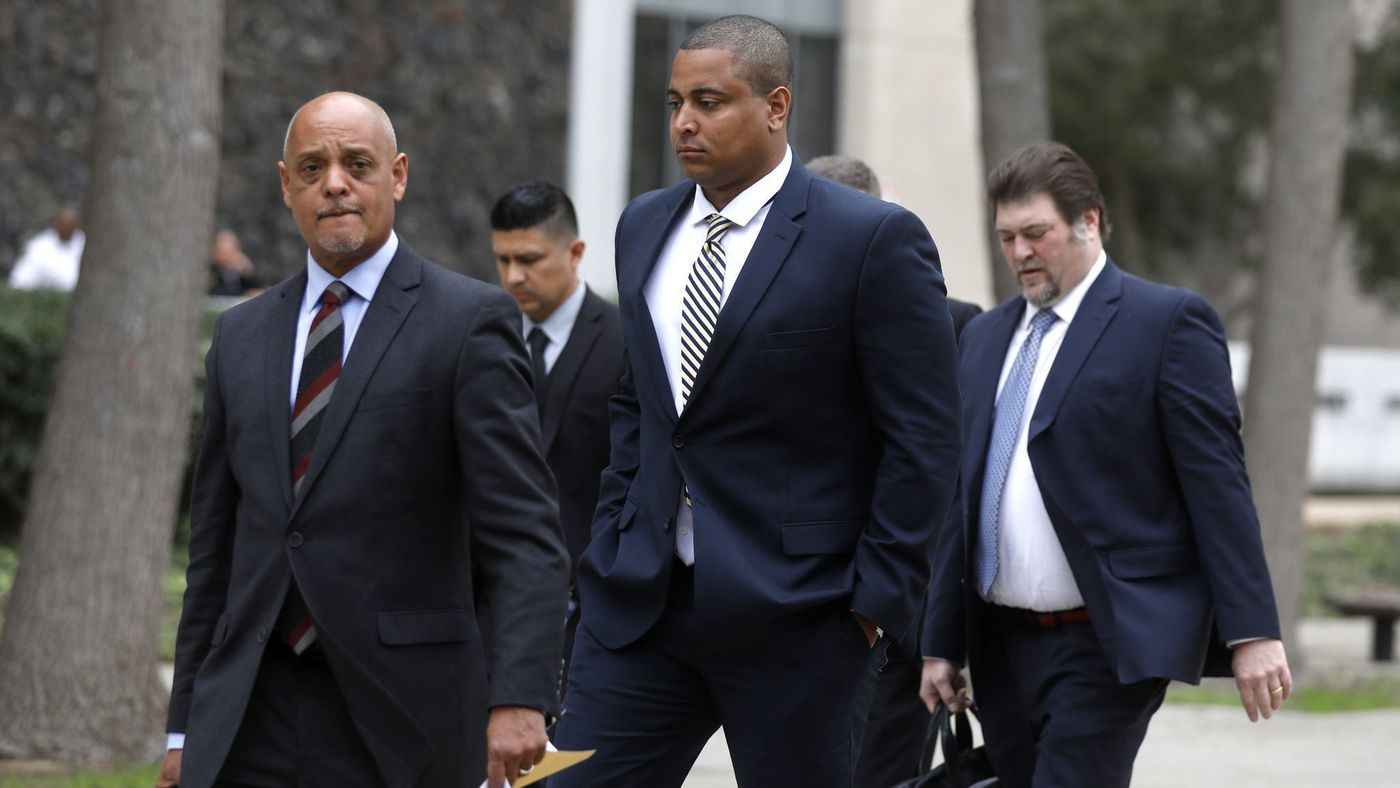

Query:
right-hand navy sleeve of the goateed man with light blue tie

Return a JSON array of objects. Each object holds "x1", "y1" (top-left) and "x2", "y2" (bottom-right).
[{"x1": 1158, "y1": 293, "x2": 1280, "y2": 641}]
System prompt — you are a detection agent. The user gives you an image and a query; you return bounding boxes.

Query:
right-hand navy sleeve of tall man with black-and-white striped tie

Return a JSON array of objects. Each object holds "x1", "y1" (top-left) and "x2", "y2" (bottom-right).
[{"x1": 851, "y1": 209, "x2": 960, "y2": 634}]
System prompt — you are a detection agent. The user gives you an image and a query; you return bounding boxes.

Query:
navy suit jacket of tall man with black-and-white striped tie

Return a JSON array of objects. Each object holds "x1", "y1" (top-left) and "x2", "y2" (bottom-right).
[{"x1": 578, "y1": 161, "x2": 959, "y2": 648}]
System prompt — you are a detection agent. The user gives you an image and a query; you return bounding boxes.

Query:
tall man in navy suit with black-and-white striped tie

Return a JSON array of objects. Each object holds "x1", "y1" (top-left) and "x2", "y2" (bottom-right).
[{"x1": 552, "y1": 17, "x2": 959, "y2": 788}]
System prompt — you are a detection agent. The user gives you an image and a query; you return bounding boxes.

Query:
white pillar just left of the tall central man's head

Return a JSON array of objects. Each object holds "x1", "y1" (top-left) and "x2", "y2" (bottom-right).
[{"x1": 564, "y1": 0, "x2": 637, "y2": 297}]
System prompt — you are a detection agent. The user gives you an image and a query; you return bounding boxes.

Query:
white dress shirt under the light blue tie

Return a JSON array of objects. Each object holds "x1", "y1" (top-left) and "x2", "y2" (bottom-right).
[{"x1": 987, "y1": 251, "x2": 1107, "y2": 612}]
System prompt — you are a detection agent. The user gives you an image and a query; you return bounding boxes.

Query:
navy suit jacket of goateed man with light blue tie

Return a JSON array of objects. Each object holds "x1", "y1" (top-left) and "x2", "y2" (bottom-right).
[{"x1": 924, "y1": 260, "x2": 1278, "y2": 683}]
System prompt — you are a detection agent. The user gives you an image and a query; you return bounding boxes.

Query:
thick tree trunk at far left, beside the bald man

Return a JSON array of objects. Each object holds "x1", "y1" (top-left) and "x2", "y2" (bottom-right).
[{"x1": 0, "y1": 0, "x2": 224, "y2": 761}]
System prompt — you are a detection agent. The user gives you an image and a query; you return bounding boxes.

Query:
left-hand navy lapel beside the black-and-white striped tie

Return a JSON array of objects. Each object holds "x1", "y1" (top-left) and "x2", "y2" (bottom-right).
[{"x1": 617, "y1": 181, "x2": 694, "y2": 421}]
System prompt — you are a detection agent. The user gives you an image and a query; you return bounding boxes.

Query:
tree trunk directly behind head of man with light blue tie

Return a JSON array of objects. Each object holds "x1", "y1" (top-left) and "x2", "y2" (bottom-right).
[{"x1": 973, "y1": 0, "x2": 1050, "y2": 301}]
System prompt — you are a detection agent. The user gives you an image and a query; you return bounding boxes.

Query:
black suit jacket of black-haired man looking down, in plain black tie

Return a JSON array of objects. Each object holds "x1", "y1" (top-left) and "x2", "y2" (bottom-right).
[{"x1": 542, "y1": 290, "x2": 622, "y2": 576}]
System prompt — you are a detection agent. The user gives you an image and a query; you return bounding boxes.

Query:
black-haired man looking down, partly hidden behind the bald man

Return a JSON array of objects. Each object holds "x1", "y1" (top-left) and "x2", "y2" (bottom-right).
[{"x1": 491, "y1": 181, "x2": 622, "y2": 677}]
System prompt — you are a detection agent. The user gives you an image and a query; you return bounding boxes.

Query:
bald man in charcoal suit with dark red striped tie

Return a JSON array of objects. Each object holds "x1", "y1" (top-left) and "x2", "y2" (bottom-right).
[{"x1": 158, "y1": 92, "x2": 568, "y2": 788}]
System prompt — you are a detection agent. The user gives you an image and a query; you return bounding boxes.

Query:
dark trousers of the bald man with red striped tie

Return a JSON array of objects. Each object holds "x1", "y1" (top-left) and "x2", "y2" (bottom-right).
[{"x1": 216, "y1": 640, "x2": 384, "y2": 788}]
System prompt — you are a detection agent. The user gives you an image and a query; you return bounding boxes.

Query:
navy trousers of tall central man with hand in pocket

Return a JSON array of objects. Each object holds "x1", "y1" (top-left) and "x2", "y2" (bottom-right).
[{"x1": 550, "y1": 564, "x2": 883, "y2": 788}]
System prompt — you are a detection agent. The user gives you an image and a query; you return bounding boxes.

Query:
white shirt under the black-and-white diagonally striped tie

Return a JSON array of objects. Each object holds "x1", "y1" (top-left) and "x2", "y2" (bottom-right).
[{"x1": 644, "y1": 147, "x2": 792, "y2": 564}]
